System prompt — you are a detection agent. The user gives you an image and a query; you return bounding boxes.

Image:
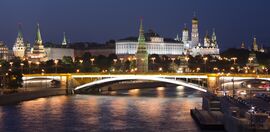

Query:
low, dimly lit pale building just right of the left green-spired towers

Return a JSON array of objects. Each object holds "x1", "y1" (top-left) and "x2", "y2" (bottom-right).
[{"x1": 45, "y1": 48, "x2": 75, "y2": 60}]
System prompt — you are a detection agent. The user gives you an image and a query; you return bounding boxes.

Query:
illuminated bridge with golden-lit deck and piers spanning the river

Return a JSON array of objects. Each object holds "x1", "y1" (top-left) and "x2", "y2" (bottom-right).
[{"x1": 23, "y1": 73, "x2": 270, "y2": 92}]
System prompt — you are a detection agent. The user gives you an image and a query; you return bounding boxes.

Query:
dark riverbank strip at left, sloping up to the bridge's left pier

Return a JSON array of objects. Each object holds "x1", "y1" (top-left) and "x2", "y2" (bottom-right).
[{"x1": 0, "y1": 88, "x2": 67, "y2": 105}]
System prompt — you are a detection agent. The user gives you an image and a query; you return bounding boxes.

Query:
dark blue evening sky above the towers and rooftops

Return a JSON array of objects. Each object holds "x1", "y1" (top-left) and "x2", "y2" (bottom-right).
[{"x1": 0, "y1": 0, "x2": 270, "y2": 49}]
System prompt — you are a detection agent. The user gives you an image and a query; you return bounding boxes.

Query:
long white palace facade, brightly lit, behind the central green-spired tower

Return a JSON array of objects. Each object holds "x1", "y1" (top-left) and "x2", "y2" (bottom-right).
[{"x1": 115, "y1": 37, "x2": 184, "y2": 55}]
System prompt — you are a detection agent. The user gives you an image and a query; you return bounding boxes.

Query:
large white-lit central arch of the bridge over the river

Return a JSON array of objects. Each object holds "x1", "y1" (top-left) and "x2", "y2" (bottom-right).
[{"x1": 75, "y1": 75, "x2": 207, "y2": 92}]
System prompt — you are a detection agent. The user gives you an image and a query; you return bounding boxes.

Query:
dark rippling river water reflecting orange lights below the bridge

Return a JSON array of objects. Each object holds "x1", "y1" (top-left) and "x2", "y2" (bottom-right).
[{"x1": 0, "y1": 87, "x2": 202, "y2": 132}]
